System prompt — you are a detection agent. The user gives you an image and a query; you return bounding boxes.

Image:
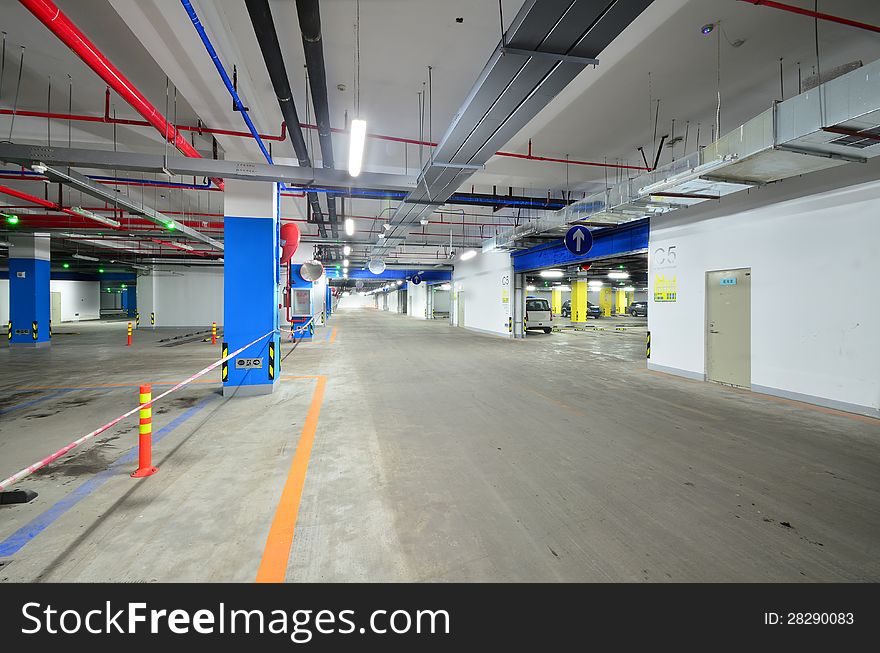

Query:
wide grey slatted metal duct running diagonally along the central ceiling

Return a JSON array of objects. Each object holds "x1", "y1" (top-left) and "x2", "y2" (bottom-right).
[{"x1": 372, "y1": 0, "x2": 652, "y2": 256}]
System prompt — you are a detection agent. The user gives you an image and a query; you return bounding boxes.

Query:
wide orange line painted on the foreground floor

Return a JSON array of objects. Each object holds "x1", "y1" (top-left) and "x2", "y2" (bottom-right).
[{"x1": 256, "y1": 376, "x2": 327, "y2": 583}]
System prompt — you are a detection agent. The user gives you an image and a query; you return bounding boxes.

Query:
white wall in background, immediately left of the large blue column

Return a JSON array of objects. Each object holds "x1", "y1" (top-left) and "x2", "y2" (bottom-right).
[{"x1": 137, "y1": 266, "x2": 223, "y2": 327}]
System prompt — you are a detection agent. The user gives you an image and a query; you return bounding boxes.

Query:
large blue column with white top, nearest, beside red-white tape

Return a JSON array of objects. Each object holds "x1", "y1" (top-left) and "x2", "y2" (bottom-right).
[{"x1": 221, "y1": 179, "x2": 281, "y2": 397}]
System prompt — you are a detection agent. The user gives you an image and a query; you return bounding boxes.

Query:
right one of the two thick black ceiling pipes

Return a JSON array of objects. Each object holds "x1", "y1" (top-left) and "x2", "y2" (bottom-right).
[{"x1": 294, "y1": 0, "x2": 339, "y2": 238}]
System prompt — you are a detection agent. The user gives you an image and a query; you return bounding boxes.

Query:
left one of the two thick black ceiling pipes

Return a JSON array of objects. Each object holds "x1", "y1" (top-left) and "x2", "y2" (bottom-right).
[{"x1": 245, "y1": 0, "x2": 335, "y2": 238}]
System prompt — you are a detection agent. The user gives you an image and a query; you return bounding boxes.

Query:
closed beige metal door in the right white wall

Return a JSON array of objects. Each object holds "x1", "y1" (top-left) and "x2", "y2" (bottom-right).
[{"x1": 706, "y1": 268, "x2": 752, "y2": 388}]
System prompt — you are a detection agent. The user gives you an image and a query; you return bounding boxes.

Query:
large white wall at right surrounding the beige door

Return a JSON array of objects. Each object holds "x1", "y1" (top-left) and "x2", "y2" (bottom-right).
[{"x1": 648, "y1": 161, "x2": 880, "y2": 416}]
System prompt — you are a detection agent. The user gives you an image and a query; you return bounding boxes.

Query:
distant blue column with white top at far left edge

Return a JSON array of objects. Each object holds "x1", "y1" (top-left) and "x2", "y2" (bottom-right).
[{"x1": 8, "y1": 234, "x2": 51, "y2": 347}]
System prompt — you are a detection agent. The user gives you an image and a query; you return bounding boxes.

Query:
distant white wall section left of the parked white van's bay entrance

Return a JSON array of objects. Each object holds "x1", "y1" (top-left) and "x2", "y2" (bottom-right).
[{"x1": 452, "y1": 252, "x2": 514, "y2": 338}]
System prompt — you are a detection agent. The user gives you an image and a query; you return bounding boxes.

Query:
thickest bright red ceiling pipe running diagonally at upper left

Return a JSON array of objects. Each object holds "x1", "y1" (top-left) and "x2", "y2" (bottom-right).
[{"x1": 19, "y1": 0, "x2": 223, "y2": 189}]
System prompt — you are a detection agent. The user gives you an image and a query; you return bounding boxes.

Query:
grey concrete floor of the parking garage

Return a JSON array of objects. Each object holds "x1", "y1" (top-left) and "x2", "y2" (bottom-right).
[{"x1": 0, "y1": 310, "x2": 880, "y2": 581}]
